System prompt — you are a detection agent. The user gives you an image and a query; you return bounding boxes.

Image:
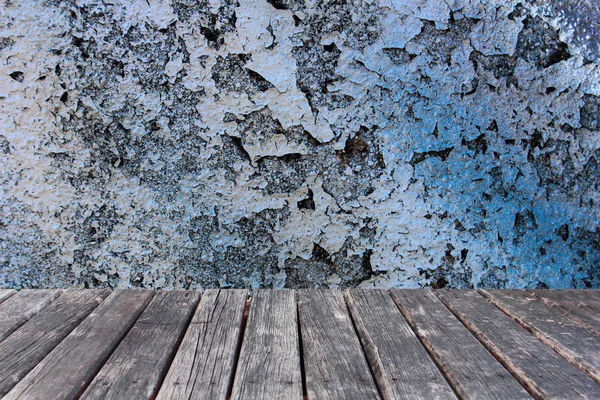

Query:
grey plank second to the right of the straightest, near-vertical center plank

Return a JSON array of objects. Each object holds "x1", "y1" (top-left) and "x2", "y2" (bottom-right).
[{"x1": 345, "y1": 289, "x2": 456, "y2": 399}]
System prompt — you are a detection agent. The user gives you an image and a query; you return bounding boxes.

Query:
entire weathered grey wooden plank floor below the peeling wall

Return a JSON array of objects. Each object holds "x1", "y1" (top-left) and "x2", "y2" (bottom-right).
[{"x1": 0, "y1": 289, "x2": 600, "y2": 400}]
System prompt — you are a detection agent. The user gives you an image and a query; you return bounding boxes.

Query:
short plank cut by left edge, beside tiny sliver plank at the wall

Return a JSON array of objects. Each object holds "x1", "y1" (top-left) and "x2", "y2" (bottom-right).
[{"x1": 0, "y1": 289, "x2": 62, "y2": 341}]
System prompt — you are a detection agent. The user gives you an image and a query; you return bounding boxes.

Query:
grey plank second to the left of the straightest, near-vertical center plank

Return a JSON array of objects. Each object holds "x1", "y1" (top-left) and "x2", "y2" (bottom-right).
[{"x1": 81, "y1": 291, "x2": 200, "y2": 400}]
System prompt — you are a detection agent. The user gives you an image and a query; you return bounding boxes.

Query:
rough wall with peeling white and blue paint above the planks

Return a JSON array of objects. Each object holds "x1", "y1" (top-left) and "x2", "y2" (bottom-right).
[{"x1": 0, "y1": 0, "x2": 600, "y2": 288}]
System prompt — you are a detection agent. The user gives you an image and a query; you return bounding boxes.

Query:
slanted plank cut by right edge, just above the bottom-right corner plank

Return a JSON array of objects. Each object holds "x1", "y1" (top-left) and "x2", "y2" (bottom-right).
[{"x1": 481, "y1": 290, "x2": 600, "y2": 383}]
